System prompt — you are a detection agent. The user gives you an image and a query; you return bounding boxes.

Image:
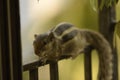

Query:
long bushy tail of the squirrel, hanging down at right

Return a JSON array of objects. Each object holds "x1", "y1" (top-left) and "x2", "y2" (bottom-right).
[{"x1": 82, "y1": 30, "x2": 113, "y2": 80}]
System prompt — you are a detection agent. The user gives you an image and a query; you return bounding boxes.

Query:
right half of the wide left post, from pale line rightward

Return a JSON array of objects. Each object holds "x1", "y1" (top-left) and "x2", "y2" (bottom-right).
[{"x1": 7, "y1": 0, "x2": 22, "y2": 80}]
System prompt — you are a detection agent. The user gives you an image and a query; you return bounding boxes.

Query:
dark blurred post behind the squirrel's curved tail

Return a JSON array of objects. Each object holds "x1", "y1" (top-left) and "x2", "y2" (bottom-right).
[{"x1": 98, "y1": 0, "x2": 118, "y2": 80}]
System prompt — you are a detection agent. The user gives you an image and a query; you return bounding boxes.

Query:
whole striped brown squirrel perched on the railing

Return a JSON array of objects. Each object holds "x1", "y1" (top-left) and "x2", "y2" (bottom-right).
[{"x1": 33, "y1": 23, "x2": 113, "y2": 80}]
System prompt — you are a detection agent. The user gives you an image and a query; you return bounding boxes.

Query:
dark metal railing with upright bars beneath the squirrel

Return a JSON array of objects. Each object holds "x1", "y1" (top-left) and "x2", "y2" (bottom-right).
[{"x1": 23, "y1": 51, "x2": 92, "y2": 80}]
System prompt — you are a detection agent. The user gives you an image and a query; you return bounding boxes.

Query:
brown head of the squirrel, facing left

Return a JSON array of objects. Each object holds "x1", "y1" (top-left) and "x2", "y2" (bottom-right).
[{"x1": 33, "y1": 32, "x2": 55, "y2": 58}]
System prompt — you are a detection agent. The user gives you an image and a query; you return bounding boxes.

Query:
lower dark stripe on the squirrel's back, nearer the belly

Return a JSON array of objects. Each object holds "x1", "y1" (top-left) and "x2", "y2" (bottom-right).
[{"x1": 62, "y1": 30, "x2": 78, "y2": 43}]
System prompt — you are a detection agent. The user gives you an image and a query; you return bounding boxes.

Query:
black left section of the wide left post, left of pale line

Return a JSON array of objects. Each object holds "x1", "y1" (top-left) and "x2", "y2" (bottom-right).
[{"x1": 0, "y1": 0, "x2": 12, "y2": 80}]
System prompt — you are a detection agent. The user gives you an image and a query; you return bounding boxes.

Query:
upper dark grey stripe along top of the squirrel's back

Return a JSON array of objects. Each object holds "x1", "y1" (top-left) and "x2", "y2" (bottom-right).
[{"x1": 54, "y1": 23, "x2": 73, "y2": 36}]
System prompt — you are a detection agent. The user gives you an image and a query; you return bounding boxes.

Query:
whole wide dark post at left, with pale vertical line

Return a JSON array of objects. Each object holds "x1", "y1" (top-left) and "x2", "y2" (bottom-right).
[{"x1": 0, "y1": 0, "x2": 22, "y2": 80}]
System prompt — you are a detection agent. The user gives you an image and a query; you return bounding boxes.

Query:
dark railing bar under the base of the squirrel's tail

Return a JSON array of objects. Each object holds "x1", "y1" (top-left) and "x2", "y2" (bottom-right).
[{"x1": 84, "y1": 47, "x2": 92, "y2": 80}]
